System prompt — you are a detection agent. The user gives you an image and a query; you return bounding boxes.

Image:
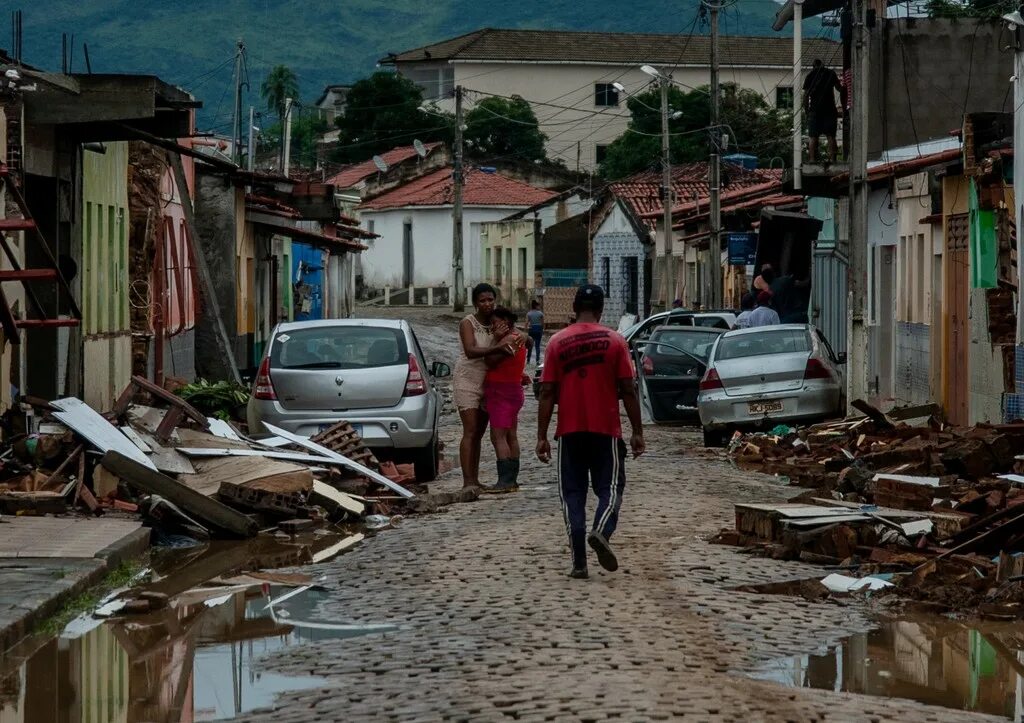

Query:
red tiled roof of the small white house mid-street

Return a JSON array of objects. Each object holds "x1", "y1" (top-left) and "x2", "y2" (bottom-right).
[{"x1": 359, "y1": 167, "x2": 558, "y2": 211}]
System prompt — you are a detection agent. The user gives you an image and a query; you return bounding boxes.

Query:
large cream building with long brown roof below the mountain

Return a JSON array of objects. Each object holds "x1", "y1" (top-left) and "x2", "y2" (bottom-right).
[{"x1": 381, "y1": 28, "x2": 842, "y2": 169}]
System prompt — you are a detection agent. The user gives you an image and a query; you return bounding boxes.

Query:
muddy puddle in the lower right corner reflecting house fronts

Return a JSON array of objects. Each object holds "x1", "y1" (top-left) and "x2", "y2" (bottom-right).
[{"x1": 751, "y1": 618, "x2": 1024, "y2": 723}]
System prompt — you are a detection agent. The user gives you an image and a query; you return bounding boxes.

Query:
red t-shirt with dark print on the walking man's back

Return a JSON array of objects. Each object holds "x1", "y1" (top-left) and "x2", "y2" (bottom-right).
[{"x1": 541, "y1": 324, "x2": 633, "y2": 438}]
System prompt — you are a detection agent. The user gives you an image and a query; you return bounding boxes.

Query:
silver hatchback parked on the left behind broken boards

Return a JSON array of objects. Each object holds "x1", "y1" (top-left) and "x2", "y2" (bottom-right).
[{"x1": 247, "y1": 318, "x2": 452, "y2": 481}]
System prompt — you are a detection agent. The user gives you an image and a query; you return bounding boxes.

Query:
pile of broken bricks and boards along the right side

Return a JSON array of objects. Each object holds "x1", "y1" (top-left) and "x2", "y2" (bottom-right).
[{"x1": 716, "y1": 402, "x2": 1024, "y2": 618}]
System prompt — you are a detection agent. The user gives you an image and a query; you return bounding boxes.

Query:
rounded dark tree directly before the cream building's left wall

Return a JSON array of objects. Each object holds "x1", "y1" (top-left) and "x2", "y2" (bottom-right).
[{"x1": 463, "y1": 95, "x2": 547, "y2": 161}]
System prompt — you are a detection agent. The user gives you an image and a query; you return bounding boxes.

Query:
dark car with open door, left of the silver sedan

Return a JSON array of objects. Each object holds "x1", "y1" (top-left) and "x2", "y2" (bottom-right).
[{"x1": 637, "y1": 327, "x2": 725, "y2": 422}]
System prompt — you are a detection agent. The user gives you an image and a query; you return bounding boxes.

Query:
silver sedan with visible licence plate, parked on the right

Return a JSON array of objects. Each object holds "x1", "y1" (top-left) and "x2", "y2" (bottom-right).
[{"x1": 697, "y1": 324, "x2": 846, "y2": 446}]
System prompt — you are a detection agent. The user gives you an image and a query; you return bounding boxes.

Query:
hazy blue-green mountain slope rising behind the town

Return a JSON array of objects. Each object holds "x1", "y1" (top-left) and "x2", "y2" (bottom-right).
[{"x1": 18, "y1": 0, "x2": 821, "y2": 131}]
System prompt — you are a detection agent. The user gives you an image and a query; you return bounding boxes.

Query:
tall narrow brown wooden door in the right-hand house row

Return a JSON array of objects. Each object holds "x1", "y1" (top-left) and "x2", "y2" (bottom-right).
[{"x1": 942, "y1": 213, "x2": 971, "y2": 425}]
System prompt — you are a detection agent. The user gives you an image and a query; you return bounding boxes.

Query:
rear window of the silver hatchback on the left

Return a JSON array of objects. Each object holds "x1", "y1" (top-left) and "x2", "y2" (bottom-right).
[{"x1": 270, "y1": 326, "x2": 409, "y2": 369}]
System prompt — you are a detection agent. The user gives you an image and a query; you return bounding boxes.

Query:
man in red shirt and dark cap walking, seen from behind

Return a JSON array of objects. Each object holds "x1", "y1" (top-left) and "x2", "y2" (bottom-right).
[{"x1": 537, "y1": 285, "x2": 644, "y2": 579}]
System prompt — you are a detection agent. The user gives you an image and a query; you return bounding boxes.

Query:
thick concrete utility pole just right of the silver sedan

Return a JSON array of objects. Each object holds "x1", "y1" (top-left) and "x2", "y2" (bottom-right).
[{"x1": 846, "y1": 0, "x2": 868, "y2": 405}]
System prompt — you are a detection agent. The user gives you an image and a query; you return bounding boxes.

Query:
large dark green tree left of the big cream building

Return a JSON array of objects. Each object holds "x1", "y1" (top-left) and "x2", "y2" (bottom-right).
[{"x1": 332, "y1": 72, "x2": 454, "y2": 163}]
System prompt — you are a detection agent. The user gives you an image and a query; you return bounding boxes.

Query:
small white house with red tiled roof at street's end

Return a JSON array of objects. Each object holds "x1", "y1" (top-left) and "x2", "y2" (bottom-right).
[{"x1": 358, "y1": 168, "x2": 558, "y2": 289}]
